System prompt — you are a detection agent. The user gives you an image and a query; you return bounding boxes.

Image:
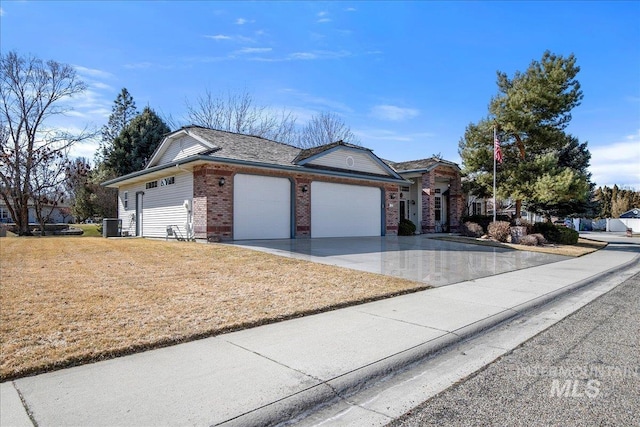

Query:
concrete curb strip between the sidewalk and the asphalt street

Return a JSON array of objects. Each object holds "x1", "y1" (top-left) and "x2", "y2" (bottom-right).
[{"x1": 216, "y1": 255, "x2": 640, "y2": 427}]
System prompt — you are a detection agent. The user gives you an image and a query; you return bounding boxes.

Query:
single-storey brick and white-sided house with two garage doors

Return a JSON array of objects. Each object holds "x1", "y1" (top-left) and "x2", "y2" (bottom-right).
[{"x1": 103, "y1": 126, "x2": 462, "y2": 240}]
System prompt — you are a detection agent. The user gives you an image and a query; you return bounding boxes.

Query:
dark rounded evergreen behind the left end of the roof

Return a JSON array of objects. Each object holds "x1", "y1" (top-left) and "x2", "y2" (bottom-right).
[{"x1": 105, "y1": 107, "x2": 171, "y2": 175}]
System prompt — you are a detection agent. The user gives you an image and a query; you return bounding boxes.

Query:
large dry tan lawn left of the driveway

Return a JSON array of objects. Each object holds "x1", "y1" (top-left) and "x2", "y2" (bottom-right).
[{"x1": 0, "y1": 237, "x2": 425, "y2": 381}]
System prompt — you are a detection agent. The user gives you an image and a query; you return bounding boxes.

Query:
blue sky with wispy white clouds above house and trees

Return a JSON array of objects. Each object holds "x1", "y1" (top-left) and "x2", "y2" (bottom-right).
[{"x1": 0, "y1": 0, "x2": 640, "y2": 190}]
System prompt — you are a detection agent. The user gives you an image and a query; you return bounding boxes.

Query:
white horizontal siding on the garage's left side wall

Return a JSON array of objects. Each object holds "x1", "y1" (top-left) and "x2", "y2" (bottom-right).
[{"x1": 118, "y1": 172, "x2": 193, "y2": 237}]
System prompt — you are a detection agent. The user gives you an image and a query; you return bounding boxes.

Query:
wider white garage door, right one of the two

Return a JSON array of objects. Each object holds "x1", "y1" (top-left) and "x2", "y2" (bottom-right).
[{"x1": 311, "y1": 182, "x2": 382, "y2": 237}]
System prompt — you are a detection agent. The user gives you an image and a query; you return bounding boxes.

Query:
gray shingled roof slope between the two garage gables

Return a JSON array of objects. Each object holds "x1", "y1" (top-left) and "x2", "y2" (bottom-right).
[{"x1": 184, "y1": 126, "x2": 301, "y2": 166}]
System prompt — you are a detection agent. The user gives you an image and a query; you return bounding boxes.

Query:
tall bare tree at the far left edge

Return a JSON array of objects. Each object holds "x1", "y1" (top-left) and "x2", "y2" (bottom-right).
[{"x1": 0, "y1": 52, "x2": 92, "y2": 235}]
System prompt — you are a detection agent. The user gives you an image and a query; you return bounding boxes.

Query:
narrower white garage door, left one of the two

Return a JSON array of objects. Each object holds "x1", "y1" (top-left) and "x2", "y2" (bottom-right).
[{"x1": 233, "y1": 174, "x2": 291, "y2": 240}]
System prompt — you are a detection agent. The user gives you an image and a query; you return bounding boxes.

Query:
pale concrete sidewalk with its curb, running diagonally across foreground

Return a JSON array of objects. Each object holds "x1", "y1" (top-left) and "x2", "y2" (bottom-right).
[{"x1": 0, "y1": 238, "x2": 640, "y2": 426}]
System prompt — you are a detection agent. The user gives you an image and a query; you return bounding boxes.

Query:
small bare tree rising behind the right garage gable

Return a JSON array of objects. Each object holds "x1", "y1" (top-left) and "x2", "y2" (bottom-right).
[{"x1": 296, "y1": 113, "x2": 360, "y2": 148}]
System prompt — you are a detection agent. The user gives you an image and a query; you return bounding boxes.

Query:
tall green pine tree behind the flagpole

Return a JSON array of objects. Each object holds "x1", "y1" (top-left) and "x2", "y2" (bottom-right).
[{"x1": 458, "y1": 51, "x2": 592, "y2": 221}]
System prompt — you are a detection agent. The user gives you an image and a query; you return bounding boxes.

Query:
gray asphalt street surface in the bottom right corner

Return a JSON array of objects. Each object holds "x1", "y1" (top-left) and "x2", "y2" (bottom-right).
[{"x1": 388, "y1": 274, "x2": 640, "y2": 427}]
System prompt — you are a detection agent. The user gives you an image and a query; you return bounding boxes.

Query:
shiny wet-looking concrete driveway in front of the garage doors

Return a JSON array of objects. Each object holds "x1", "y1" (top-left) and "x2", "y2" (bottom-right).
[{"x1": 233, "y1": 234, "x2": 569, "y2": 286}]
